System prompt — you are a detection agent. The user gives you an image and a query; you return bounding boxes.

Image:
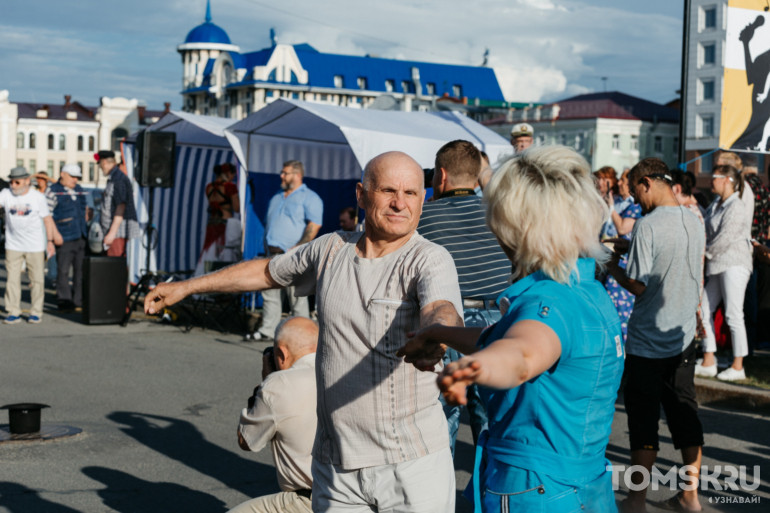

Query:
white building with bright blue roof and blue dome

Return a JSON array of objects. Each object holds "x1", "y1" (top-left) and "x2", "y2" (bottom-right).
[{"x1": 177, "y1": 0, "x2": 513, "y2": 119}]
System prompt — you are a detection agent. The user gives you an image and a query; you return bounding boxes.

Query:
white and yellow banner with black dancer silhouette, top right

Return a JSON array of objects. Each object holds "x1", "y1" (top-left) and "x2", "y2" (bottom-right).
[{"x1": 719, "y1": 0, "x2": 770, "y2": 153}]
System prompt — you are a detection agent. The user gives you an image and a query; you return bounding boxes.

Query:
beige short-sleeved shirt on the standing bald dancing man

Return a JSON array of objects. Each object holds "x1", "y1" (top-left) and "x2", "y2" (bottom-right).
[{"x1": 270, "y1": 232, "x2": 462, "y2": 469}]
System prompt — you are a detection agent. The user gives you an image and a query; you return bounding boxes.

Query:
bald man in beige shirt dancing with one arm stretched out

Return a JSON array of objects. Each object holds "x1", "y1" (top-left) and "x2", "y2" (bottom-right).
[{"x1": 145, "y1": 152, "x2": 462, "y2": 513}]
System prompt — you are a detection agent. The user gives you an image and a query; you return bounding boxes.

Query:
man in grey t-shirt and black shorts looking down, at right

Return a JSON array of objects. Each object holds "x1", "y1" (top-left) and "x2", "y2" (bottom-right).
[{"x1": 608, "y1": 158, "x2": 706, "y2": 512}]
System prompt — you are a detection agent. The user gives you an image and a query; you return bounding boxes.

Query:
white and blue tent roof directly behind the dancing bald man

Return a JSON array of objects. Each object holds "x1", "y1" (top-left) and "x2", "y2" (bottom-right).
[{"x1": 225, "y1": 99, "x2": 512, "y2": 179}]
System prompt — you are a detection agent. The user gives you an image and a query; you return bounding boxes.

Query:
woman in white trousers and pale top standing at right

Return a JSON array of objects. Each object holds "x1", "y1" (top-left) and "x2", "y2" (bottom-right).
[{"x1": 695, "y1": 165, "x2": 752, "y2": 381}]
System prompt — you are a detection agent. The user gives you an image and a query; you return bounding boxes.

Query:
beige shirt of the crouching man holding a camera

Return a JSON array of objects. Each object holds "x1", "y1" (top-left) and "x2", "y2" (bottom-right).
[{"x1": 238, "y1": 353, "x2": 316, "y2": 492}]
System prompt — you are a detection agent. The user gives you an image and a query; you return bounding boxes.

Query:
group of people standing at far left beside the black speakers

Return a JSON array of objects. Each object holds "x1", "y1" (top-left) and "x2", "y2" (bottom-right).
[{"x1": 0, "y1": 150, "x2": 141, "y2": 324}]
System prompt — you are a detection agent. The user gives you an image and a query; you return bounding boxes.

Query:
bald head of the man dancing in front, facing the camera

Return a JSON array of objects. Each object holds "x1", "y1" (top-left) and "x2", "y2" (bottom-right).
[{"x1": 356, "y1": 157, "x2": 425, "y2": 240}]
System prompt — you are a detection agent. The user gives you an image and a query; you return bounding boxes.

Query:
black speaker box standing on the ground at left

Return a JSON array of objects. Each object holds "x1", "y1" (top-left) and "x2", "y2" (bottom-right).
[{"x1": 83, "y1": 256, "x2": 128, "y2": 324}]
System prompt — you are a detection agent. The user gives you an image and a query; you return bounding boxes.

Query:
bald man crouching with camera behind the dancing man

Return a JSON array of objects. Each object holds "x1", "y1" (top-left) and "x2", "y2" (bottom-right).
[{"x1": 230, "y1": 317, "x2": 318, "y2": 513}]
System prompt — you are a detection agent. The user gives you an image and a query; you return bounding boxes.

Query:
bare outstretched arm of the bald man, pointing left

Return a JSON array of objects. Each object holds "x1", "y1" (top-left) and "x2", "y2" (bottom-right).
[{"x1": 144, "y1": 258, "x2": 280, "y2": 314}]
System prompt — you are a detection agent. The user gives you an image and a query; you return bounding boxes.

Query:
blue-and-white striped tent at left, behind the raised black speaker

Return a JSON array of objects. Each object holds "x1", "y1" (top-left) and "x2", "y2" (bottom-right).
[{"x1": 123, "y1": 111, "x2": 236, "y2": 282}]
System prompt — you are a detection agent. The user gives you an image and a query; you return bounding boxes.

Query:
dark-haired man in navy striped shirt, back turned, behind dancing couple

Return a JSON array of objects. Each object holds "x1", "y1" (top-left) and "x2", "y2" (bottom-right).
[{"x1": 417, "y1": 140, "x2": 511, "y2": 453}]
